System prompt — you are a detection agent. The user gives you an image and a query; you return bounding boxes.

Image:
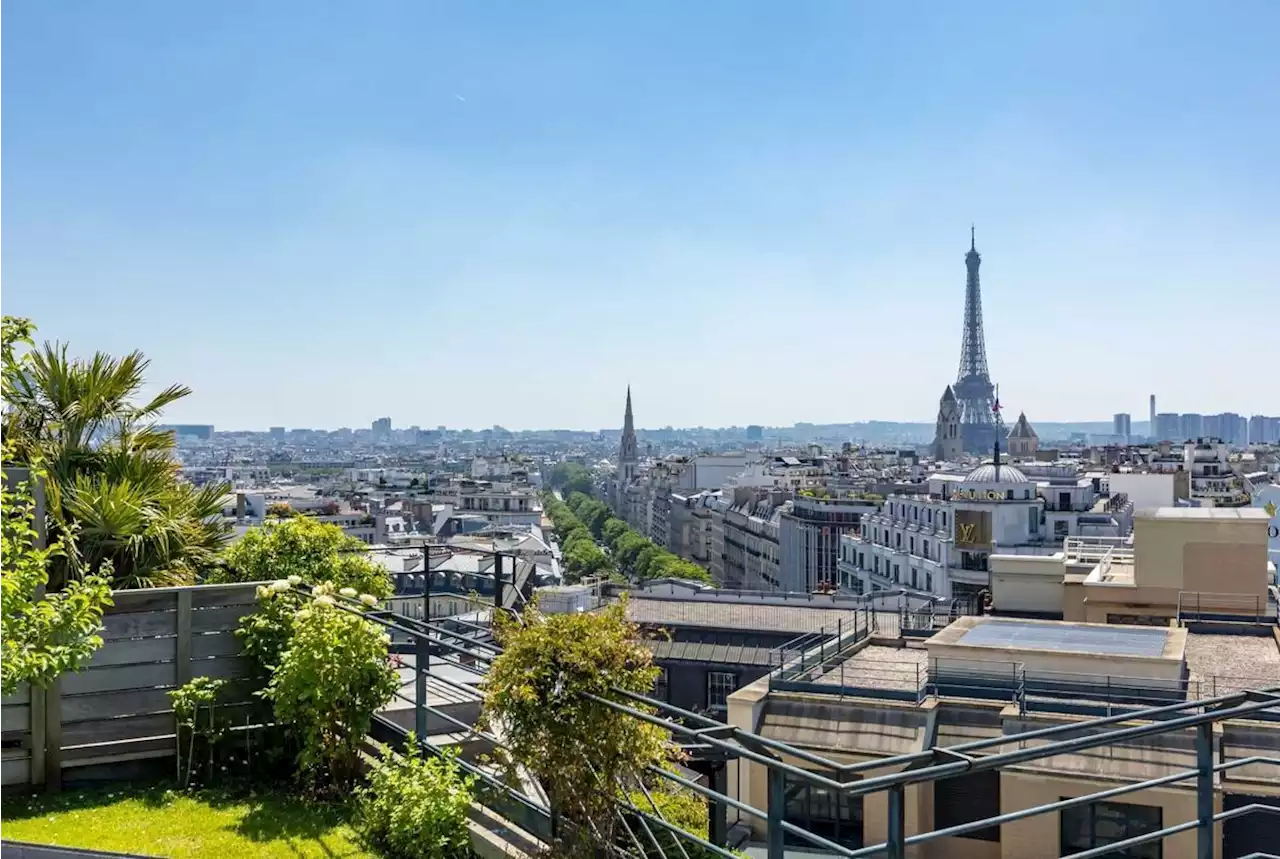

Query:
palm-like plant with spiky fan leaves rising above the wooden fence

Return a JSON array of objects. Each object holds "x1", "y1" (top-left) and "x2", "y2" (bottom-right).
[{"x1": 0, "y1": 343, "x2": 227, "y2": 588}]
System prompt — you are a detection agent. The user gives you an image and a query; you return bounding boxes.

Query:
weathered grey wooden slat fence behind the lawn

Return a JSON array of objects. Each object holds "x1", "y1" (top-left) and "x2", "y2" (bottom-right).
[{"x1": 0, "y1": 584, "x2": 256, "y2": 789}]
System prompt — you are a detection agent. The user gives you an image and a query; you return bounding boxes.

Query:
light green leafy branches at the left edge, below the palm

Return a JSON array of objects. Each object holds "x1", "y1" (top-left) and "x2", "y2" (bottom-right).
[{"x1": 0, "y1": 460, "x2": 111, "y2": 698}]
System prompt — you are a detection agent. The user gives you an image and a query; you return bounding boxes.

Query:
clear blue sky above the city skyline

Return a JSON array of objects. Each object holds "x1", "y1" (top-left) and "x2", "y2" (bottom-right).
[{"x1": 0, "y1": 0, "x2": 1280, "y2": 428}]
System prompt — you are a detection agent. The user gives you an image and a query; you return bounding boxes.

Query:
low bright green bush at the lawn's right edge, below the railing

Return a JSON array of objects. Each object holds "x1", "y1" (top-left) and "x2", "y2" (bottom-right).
[{"x1": 357, "y1": 734, "x2": 475, "y2": 859}]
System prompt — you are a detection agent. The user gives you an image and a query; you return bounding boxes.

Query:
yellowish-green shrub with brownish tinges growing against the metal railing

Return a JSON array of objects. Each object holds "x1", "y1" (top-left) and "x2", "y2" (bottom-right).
[{"x1": 480, "y1": 599, "x2": 675, "y2": 856}]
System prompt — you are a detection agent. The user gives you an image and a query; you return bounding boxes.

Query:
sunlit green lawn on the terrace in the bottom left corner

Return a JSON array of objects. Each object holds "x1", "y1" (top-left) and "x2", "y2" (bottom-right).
[{"x1": 0, "y1": 789, "x2": 378, "y2": 859}]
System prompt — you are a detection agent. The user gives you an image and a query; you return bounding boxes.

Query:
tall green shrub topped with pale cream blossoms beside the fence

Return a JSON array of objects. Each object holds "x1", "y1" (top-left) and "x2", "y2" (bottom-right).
[{"x1": 260, "y1": 581, "x2": 399, "y2": 791}]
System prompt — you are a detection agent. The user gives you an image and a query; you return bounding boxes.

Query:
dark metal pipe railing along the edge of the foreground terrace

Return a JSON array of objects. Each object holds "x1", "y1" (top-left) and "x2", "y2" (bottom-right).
[{"x1": 282, "y1": 573, "x2": 1280, "y2": 859}]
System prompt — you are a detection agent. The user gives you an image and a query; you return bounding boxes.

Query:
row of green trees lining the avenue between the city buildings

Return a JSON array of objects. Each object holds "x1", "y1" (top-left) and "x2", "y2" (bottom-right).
[{"x1": 545, "y1": 493, "x2": 713, "y2": 584}]
